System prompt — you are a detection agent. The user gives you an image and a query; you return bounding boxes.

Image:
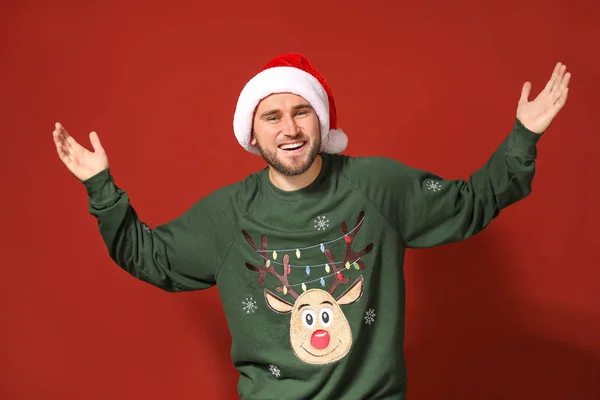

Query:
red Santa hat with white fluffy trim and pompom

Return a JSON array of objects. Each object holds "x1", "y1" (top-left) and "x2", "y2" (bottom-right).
[{"x1": 233, "y1": 53, "x2": 348, "y2": 154}]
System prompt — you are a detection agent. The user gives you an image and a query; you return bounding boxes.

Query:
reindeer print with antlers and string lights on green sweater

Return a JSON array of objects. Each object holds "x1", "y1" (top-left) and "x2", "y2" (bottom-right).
[{"x1": 243, "y1": 212, "x2": 373, "y2": 364}]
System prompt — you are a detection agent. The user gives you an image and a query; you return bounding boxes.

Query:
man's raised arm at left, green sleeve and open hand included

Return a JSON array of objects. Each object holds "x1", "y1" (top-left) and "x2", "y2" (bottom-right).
[{"x1": 53, "y1": 123, "x2": 227, "y2": 292}]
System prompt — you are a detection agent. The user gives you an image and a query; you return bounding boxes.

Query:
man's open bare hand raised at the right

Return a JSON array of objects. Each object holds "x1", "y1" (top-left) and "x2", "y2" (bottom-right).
[{"x1": 517, "y1": 62, "x2": 571, "y2": 134}]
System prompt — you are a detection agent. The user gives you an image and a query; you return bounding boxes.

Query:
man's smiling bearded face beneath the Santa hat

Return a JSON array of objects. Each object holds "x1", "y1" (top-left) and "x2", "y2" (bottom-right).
[{"x1": 251, "y1": 93, "x2": 321, "y2": 176}]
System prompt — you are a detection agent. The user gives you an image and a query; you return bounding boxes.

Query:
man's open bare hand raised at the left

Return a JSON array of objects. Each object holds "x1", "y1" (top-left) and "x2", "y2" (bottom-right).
[{"x1": 52, "y1": 122, "x2": 108, "y2": 181}]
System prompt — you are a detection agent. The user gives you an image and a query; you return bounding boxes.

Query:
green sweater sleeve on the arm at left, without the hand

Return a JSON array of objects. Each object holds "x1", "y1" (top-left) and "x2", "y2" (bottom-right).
[{"x1": 83, "y1": 169, "x2": 231, "y2": 292}]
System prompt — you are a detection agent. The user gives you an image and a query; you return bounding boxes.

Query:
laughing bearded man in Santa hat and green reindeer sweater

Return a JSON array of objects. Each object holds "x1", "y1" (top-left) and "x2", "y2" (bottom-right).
[{"x1": 53, "y1": 54, "x2": 571, "y2": 400}]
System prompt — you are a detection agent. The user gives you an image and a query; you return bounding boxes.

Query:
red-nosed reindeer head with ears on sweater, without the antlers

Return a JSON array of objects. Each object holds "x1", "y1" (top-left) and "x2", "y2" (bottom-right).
[{"x1": 265, "y1": 277, "x2": 363, "y2": 364}]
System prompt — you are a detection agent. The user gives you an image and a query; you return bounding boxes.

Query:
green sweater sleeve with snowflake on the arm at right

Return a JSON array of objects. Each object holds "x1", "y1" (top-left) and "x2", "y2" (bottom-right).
[{"x1": 396, "y1": 119, "x2": 541, "y2": 248}]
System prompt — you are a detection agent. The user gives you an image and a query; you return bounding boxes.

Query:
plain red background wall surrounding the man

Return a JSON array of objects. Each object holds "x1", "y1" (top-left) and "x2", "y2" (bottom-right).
[{"x1": 0, "y1": 0, "x2": 600, "y2": 400}]
